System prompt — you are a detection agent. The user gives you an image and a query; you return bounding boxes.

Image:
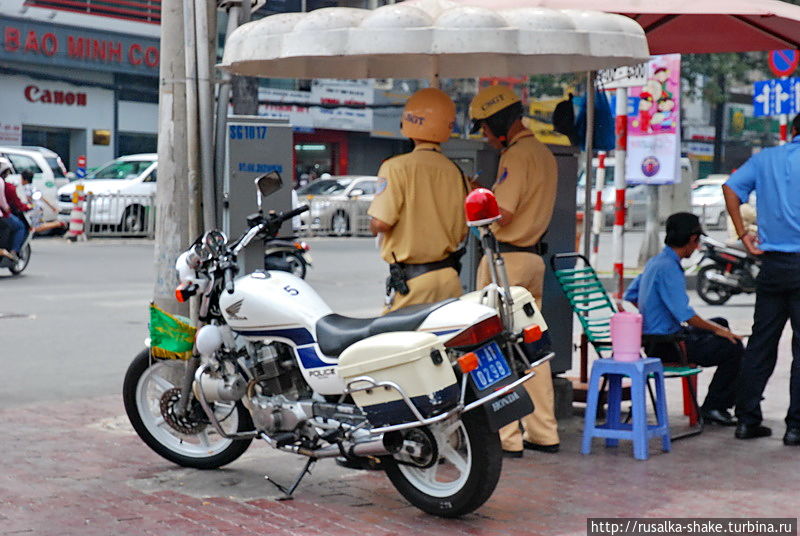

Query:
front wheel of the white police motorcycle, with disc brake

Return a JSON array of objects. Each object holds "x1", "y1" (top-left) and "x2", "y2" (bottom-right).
[{"x1": 122, "y1": 349, "x2": 253, "y2": 469}]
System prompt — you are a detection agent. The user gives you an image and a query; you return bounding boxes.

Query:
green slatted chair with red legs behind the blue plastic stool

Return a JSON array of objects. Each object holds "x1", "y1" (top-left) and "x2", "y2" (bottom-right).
[{"x1": 550, "y1": 253, "x2": 704, "y2": 440}]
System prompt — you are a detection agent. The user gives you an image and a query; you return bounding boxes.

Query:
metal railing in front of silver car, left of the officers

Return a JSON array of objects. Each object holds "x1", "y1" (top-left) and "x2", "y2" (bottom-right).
[{"x1": 298, "y1": 199, "x2": 372, "y2": 236}]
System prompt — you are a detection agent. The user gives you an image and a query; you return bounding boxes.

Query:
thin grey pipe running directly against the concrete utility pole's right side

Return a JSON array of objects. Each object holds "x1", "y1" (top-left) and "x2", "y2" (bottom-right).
[{"x1": 183, "y1": 0, "x2": 203, "y2": 241}]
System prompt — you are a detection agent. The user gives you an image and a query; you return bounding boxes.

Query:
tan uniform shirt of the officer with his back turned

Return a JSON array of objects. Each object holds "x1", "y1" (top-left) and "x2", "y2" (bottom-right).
[{"x1": 368, "y1": 143, "x2": 467, "y2": 264}]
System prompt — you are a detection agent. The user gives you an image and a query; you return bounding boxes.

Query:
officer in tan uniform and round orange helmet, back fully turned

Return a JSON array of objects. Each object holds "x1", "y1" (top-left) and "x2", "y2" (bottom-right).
[{"x1": 368, "y1": 88, "x2": 469, "y2": 312}]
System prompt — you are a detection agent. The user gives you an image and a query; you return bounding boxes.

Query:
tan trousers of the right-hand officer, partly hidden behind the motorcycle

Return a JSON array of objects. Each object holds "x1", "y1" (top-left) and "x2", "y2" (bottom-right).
[{"x1": 477, "y1": 251, "x2": 560, "y2": 452}]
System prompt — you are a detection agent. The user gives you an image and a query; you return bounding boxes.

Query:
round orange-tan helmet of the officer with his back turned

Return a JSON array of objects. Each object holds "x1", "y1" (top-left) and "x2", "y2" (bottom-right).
[{"x1": 400, "y1": 87, "x2": 456, "y2": 143}]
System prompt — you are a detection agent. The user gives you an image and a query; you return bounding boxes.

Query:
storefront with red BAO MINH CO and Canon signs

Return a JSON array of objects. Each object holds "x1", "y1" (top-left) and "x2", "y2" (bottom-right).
[{"x1": 0, "y1": 16, "x2": 159, "y2": 169}]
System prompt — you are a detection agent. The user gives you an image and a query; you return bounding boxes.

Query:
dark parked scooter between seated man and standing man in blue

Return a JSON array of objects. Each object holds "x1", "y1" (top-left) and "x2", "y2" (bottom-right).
[{"x1": 692, "y1": 236, "x2": 760, "y2": 305}]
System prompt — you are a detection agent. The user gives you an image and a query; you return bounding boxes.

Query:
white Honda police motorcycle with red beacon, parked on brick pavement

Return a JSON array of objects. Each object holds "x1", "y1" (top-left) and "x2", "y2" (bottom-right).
[{"x1": 123, "y1": 173, "x2": 553, "y2": 517}]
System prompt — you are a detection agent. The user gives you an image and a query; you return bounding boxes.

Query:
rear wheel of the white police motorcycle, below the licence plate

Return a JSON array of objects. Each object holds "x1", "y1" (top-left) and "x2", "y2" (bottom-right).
[{"x1": 382, "y1": 409, "x2": 503, "y2": 517}]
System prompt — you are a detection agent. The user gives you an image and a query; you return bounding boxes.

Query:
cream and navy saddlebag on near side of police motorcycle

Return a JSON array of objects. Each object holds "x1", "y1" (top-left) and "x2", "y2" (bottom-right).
[{"x1": 337, "y1": 331, "x2": 460, "y2": 426}]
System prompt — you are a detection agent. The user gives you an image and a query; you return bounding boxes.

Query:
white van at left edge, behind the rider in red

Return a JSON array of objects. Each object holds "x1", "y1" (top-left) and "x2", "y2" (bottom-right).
[{"x1": 0, "y1": 145, "x2": 69, "y2": 221}]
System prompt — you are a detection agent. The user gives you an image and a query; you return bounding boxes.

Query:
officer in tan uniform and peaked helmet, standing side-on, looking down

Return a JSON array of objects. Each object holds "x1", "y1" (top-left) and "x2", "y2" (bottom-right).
[{"x1": 469, "y1": 85, "x2": 559, "y2": 457}]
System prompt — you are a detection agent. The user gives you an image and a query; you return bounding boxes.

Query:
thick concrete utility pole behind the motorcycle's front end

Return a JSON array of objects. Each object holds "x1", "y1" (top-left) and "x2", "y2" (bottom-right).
[{"x1": 153, "y1": 0, "x2": 189, "y2": 315}]
